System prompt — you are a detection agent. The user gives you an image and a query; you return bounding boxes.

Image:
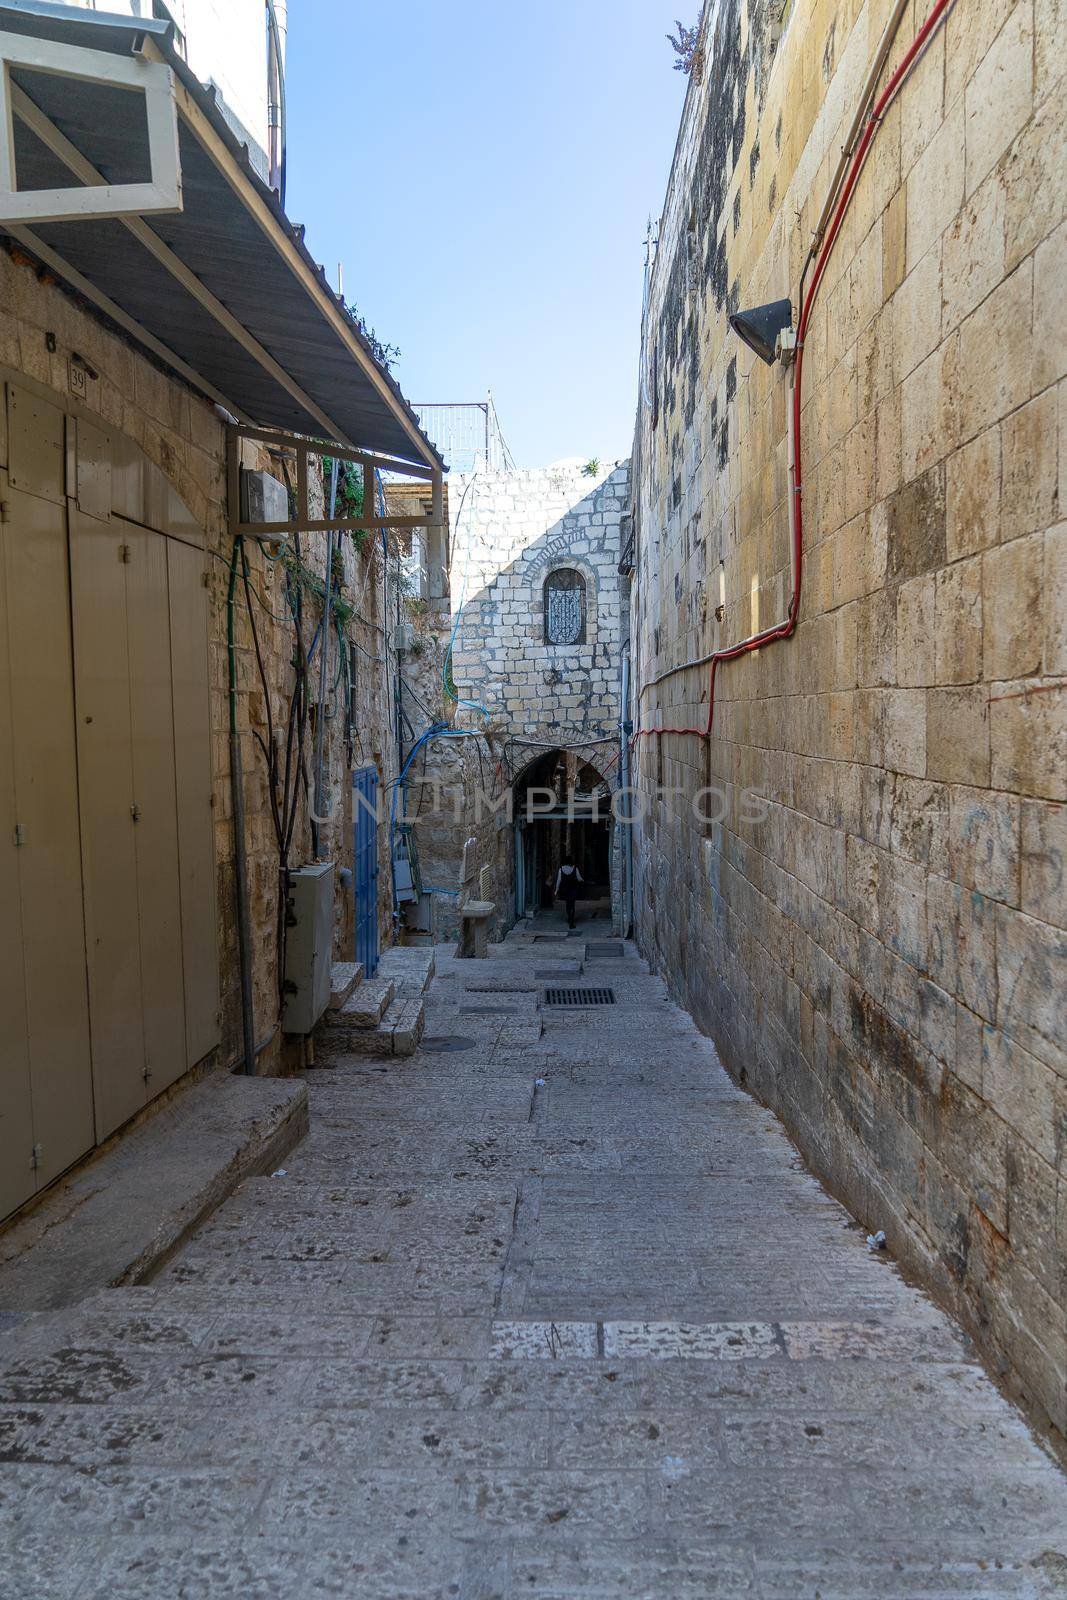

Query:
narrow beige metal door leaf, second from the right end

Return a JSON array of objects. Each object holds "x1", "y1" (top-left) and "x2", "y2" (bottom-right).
[{"x1": 125, "y1": 526, "x2": 187, "y2": 1096}]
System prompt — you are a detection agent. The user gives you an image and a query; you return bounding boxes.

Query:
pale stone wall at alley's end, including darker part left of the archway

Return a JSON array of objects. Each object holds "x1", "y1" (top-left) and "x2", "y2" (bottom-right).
[{"x1": 404, "y1": 462, "x2": 629, "y2": 939}]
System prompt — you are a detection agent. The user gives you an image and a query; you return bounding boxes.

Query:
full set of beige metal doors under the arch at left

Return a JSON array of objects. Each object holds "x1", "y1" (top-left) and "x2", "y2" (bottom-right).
[{"x1": 0, "y1": 374, "x2": 219, "y2": 1218}]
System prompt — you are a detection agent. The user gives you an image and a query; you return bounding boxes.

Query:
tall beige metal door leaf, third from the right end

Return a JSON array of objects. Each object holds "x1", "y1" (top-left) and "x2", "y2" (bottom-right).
[{"x1": 69, "y1": 501, "x2": 147, "y2": 1139}]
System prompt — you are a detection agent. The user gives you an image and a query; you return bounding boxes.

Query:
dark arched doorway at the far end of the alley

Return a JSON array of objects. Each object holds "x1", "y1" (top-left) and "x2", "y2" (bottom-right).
[{"x1": 514, "y1": 749, "x2": 613, "y2": 918}]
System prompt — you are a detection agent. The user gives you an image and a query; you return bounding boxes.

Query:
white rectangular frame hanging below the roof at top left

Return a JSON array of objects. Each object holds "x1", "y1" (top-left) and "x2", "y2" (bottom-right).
[{"x1": 0, "y1": 32, "x2": 182, "y2": 222}]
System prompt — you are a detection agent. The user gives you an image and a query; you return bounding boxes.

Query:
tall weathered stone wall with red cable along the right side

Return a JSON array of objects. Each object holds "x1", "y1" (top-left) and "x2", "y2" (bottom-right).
[{"x1": 633, "y1": 0, "x2": 1067, "y2": 1430}]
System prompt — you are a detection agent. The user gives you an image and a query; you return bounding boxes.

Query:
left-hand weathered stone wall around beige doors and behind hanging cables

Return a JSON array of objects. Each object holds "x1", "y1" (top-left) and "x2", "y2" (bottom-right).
[{"x1": 0, "y1": 250, "x2": 395, "y2": 1070}]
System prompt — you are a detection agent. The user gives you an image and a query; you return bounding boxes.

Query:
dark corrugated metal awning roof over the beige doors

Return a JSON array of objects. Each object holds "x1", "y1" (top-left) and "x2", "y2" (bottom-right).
[{"x1": 0, "y1": 0, "x2": 442, "y2": 466}]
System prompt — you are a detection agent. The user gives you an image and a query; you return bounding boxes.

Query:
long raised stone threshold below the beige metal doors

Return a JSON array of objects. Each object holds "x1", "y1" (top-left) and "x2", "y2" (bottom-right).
[{"x1": 0, "y1": 1074, "x2": 307, "y2": 1331}]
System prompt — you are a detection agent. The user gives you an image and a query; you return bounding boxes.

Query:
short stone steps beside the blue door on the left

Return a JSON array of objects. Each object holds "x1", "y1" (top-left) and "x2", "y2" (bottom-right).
[{"x1": 318, "y1": 946, "x2": 435, "y2": 1059}]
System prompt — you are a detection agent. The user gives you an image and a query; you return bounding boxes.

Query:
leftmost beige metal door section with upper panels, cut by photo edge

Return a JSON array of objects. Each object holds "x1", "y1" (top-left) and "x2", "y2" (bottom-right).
[{"x1": 0, "y1": 389, "x2": 94, "y2": 1214}]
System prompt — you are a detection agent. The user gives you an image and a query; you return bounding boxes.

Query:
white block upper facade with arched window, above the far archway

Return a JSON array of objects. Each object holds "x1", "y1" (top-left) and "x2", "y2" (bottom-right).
[{"x1": 450, "y1": 462, "x2": 629, "y2": 744}]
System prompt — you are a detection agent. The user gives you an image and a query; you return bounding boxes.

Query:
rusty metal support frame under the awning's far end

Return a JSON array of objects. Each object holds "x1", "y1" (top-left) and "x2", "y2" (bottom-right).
[{"x1": 226, "y1": 422, "x2": 445, "y2": 539}]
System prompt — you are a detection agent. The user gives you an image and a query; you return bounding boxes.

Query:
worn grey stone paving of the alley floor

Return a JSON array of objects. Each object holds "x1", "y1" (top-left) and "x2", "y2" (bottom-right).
[{"x1": 0, "y1": 923, "x2": 1067, "y2": 1600}]
